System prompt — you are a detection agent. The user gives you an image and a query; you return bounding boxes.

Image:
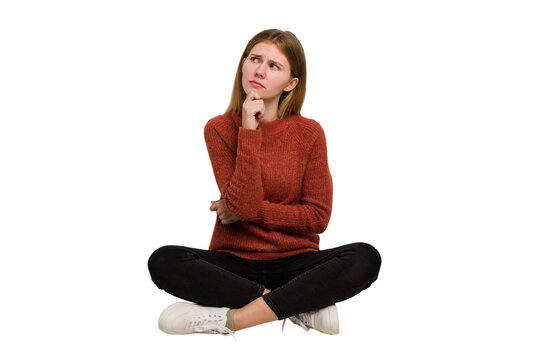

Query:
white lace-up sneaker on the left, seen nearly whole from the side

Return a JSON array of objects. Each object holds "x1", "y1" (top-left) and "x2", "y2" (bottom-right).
[{"x1": 158, "y1": 302, "x2": 234, "y2": 337}]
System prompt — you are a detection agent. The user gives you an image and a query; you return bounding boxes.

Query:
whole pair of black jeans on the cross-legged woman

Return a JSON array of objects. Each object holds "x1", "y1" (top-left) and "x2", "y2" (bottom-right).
[{"x1": 148, "y1": 243, "x2": 381, "y2": 320}]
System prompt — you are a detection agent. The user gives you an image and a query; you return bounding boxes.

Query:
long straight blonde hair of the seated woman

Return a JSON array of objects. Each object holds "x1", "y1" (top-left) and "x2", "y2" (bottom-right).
[{"x1": 225, "y1": 29, "x2": 307, "y2": 118}]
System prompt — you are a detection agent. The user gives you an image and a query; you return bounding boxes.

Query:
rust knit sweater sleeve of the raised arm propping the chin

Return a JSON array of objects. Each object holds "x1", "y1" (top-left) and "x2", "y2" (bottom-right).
[{"x1": 204, "y1": 122, "x2": 264, "y2": 221}]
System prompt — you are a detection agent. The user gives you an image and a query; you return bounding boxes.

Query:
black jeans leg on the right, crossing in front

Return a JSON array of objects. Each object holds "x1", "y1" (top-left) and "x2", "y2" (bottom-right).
[{"x1": 263, "y1": 243, "x2": 381, "y2": 319}]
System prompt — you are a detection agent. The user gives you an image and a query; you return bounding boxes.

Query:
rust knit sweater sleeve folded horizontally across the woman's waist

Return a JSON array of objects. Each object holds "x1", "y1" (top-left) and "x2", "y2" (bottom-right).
[{"x1": 254, "y1": 128, "x2": 333, "y2": 234}]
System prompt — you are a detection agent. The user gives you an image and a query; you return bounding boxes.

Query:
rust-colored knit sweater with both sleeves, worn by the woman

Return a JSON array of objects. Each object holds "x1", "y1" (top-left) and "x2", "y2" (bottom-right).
[{"x1": 204, "y1": 113, "x2": 332, "y2": 260}]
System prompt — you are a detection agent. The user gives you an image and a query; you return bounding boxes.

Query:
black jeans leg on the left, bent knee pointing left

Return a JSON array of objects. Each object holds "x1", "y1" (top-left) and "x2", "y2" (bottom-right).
[{"x1": 148, "y1": 245, "x2": 264, "y2": 308}]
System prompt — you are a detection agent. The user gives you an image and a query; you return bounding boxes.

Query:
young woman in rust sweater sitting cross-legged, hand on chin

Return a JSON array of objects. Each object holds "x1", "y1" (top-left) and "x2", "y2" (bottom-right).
[{"x1": 148, "y1": 29, "x2": 381, "y2": 334}]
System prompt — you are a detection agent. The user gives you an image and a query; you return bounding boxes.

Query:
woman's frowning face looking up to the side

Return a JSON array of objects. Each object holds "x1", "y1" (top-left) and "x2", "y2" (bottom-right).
[{"x1": 242, "y1": 41, "x2": 298, "y2": 101}]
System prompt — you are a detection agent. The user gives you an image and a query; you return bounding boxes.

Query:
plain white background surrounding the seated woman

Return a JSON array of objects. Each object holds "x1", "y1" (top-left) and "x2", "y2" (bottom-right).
[{"x1": 0, "y1": 0, "x2": 540, "y2": 359}]
